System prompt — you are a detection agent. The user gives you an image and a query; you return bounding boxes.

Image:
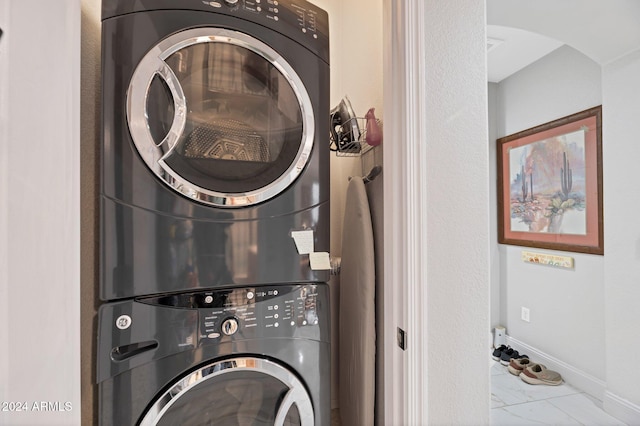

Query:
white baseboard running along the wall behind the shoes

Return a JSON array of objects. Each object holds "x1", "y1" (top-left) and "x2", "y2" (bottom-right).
[{"x1": 506, "y1": 336, "x2": 607, "y2": 401}]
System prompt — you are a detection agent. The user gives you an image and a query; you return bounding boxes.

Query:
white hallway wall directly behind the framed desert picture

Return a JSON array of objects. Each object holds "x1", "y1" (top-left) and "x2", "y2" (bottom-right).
[{"x1": 491, "y1": 46, "x2": 607, "y2": 380}]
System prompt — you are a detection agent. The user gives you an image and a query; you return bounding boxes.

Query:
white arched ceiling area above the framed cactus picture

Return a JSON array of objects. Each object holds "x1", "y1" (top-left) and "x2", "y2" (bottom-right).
[{"x1": 487, "y1": 0, "x2": 640, "y2": 82}]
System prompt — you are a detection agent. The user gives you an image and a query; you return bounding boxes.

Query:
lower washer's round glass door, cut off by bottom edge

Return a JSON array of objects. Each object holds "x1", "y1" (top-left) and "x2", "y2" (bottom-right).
[{"x1": 140, "y1": 357, "x2": 314, "y2": 426}]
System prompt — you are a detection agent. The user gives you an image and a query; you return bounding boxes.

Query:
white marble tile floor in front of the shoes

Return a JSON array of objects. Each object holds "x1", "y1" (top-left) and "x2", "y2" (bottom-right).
[{"x1": 490, "y1": 360, "x2": 624, "y2": 426}]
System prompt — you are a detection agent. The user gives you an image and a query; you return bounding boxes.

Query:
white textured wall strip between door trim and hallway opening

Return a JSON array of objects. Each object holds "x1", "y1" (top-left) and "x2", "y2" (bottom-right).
[{"x1": 422, "y1": 0, "x2": 489, "y2": 424}]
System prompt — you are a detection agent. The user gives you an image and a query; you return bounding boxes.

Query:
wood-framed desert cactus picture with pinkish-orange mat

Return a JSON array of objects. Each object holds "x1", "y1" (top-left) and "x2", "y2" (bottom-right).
[{"x1": 496, "y1": 106, "x2": 604, "y2": 255}]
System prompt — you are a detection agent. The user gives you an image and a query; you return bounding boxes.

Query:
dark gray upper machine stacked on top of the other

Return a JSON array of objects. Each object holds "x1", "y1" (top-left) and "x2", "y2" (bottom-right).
[{"x1": 100, "y1": 0, "x2": 330, "y2": 301}]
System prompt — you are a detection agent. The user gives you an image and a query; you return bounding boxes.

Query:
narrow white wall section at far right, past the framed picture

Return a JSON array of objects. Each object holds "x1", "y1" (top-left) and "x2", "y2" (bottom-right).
[{"x1": 602, "y1": 51, "x2": 640, "y2": 424}]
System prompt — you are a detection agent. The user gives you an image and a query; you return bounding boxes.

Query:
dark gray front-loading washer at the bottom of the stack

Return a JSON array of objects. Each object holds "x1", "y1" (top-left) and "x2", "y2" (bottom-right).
[{"x1": 97, "y1": 284, "x2": 331, "y2": 426}]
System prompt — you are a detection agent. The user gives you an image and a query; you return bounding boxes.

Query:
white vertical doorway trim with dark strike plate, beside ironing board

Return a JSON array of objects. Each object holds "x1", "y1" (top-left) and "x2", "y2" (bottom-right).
[{"x1": 383, "y1": 0, "x2": 428, "y2": 424}]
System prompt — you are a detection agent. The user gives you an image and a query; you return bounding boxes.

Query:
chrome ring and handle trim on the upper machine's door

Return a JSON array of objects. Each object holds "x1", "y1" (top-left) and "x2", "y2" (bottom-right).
[{"x1": 126, "y1": 27, "x2": 315, "y2": 207}]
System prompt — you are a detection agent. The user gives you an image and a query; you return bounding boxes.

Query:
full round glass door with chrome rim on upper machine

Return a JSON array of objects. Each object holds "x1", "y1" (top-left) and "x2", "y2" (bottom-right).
[{"x1": 126, "y1": 28, "x2": 314, "y2": 207}]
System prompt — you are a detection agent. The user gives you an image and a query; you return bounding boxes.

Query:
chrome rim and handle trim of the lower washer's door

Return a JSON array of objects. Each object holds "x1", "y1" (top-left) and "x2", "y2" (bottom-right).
[{"x1": 139, "y1": 357, "x2": 315, "y2": 426}]
